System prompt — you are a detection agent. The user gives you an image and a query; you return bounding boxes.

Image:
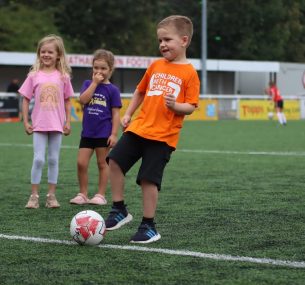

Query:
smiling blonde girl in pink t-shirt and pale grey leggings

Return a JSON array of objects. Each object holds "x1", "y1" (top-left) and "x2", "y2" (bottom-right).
[{"x1": 18, "y1": 35, "x2": 74, "y2": 209}]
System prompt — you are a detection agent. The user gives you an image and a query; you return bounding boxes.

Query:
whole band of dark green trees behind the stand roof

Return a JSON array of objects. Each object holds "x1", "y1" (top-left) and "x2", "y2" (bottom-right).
[{"x1": 0, "y1": 0, "x2": 305, "y2": 62}]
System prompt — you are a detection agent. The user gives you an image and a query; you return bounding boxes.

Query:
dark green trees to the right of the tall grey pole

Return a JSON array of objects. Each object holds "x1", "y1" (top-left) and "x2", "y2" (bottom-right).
[{"x1": 208, "y1": 0, "x2": 305, "y2": 62}]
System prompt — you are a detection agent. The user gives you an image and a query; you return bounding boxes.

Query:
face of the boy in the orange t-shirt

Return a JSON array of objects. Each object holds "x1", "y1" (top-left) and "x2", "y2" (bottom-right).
[{"x1": 157, "y1": 25, "x2": 188, "y2": 62}]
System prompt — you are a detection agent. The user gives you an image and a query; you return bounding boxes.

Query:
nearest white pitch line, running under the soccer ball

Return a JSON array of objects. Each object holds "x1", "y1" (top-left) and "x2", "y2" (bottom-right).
[{"x1": 0, "y1": 234, "x2": 305, "y2": 268}]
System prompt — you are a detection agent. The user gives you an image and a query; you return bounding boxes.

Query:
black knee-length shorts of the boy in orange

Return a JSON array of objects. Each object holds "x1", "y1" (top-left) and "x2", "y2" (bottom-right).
[{"x1": 107, "y1": 132, "x2": 174, "y2": 191}]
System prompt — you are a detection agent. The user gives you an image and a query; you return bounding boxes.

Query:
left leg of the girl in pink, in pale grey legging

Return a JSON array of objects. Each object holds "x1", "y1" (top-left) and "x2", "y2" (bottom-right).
[{"x1": 31, "y1": 132, "x2": 48, "y2": 195}]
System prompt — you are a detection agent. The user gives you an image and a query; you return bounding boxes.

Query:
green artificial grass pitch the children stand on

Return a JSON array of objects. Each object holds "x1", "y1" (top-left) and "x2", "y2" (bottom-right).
[{"x1": 0, "y1": 120, "x2": 305, "y2": 285}]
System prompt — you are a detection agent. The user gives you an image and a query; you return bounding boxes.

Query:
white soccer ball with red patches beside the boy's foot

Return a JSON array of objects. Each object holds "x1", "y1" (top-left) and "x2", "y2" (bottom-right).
[{"x1": 70, "y1": 210, "x2": 106, "y2": 245}]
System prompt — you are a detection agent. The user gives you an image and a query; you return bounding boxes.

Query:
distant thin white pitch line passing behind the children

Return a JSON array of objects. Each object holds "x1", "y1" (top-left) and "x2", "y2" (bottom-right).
[{"x1": 0, "y1": 143, "x2": 305, "y2": 156}]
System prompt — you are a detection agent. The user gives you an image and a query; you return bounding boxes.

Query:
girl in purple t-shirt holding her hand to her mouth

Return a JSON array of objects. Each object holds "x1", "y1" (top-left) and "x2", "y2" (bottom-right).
[{"x1": 70, "y1": 49, "x2": 122, "y2": 205}]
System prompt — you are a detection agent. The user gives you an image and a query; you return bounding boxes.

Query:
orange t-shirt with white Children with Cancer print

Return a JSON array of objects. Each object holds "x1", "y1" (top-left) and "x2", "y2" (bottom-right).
[{"x1": 126, "y1": 56, "x2": 200, "y2": 148}]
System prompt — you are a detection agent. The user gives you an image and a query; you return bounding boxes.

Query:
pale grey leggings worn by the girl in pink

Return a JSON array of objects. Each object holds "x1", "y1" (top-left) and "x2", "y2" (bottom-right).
[{"x1": 31, "y1": 132, "x2": 62, "y2": 184}]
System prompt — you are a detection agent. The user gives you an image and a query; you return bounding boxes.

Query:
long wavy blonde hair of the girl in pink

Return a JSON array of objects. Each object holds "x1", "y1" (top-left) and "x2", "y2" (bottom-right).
[{"x1": 30, "y1": 34, "x2": 71, "y2": 77}]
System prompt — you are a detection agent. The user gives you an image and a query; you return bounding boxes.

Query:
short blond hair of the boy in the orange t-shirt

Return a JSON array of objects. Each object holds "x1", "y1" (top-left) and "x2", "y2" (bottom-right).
[{"x1": 157, "y1": 15, "x2": 193, "y2": 46}]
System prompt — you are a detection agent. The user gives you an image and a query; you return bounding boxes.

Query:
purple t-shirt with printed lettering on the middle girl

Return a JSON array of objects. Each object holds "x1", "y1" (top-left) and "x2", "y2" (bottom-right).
[{"x1": 80, "y1": 80, "x2": 122, "y2": 138}]
